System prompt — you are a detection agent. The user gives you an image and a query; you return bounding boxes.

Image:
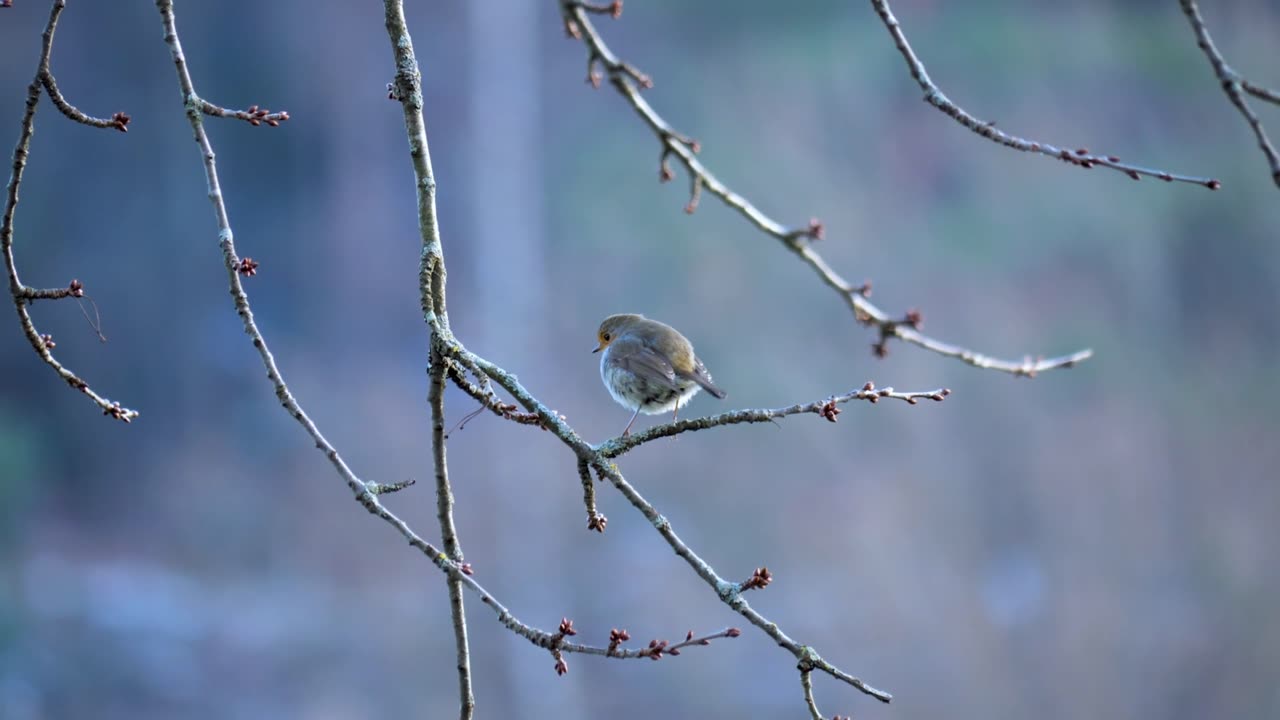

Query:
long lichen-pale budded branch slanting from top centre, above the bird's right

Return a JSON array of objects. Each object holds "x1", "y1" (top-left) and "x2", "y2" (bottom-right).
[{"x1": 559, "y1": 0, "x2": 1093, "y2": 377}]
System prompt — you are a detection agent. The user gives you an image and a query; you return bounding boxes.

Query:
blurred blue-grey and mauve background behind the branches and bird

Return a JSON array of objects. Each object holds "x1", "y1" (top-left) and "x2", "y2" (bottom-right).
[{"x1": 0, "y1": 0, "x2": 1280, "y2": 720}]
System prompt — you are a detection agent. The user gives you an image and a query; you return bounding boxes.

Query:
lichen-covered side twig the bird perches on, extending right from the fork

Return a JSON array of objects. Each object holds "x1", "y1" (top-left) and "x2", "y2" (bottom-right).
[{"x1": 595, "y1": 383, "x2": 951, "y2": 459}]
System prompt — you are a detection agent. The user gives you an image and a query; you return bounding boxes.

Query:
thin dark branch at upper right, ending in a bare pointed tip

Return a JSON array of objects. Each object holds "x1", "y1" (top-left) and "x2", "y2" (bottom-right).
[{"x1": 872, "y1": 0, "x2": 1222, "y2": 190}]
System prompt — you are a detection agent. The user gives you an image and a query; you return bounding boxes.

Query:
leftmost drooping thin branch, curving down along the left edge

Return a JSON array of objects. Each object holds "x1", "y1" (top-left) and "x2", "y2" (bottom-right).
[{"x1": 0, "y1": 0, "x2": 138, "y2": 423}]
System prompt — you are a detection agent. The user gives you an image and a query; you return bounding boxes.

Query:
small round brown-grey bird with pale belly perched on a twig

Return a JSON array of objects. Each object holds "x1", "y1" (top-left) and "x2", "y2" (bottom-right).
[{"x1": 591, "y1": 315, "x2": 724, "y2": 437}]
